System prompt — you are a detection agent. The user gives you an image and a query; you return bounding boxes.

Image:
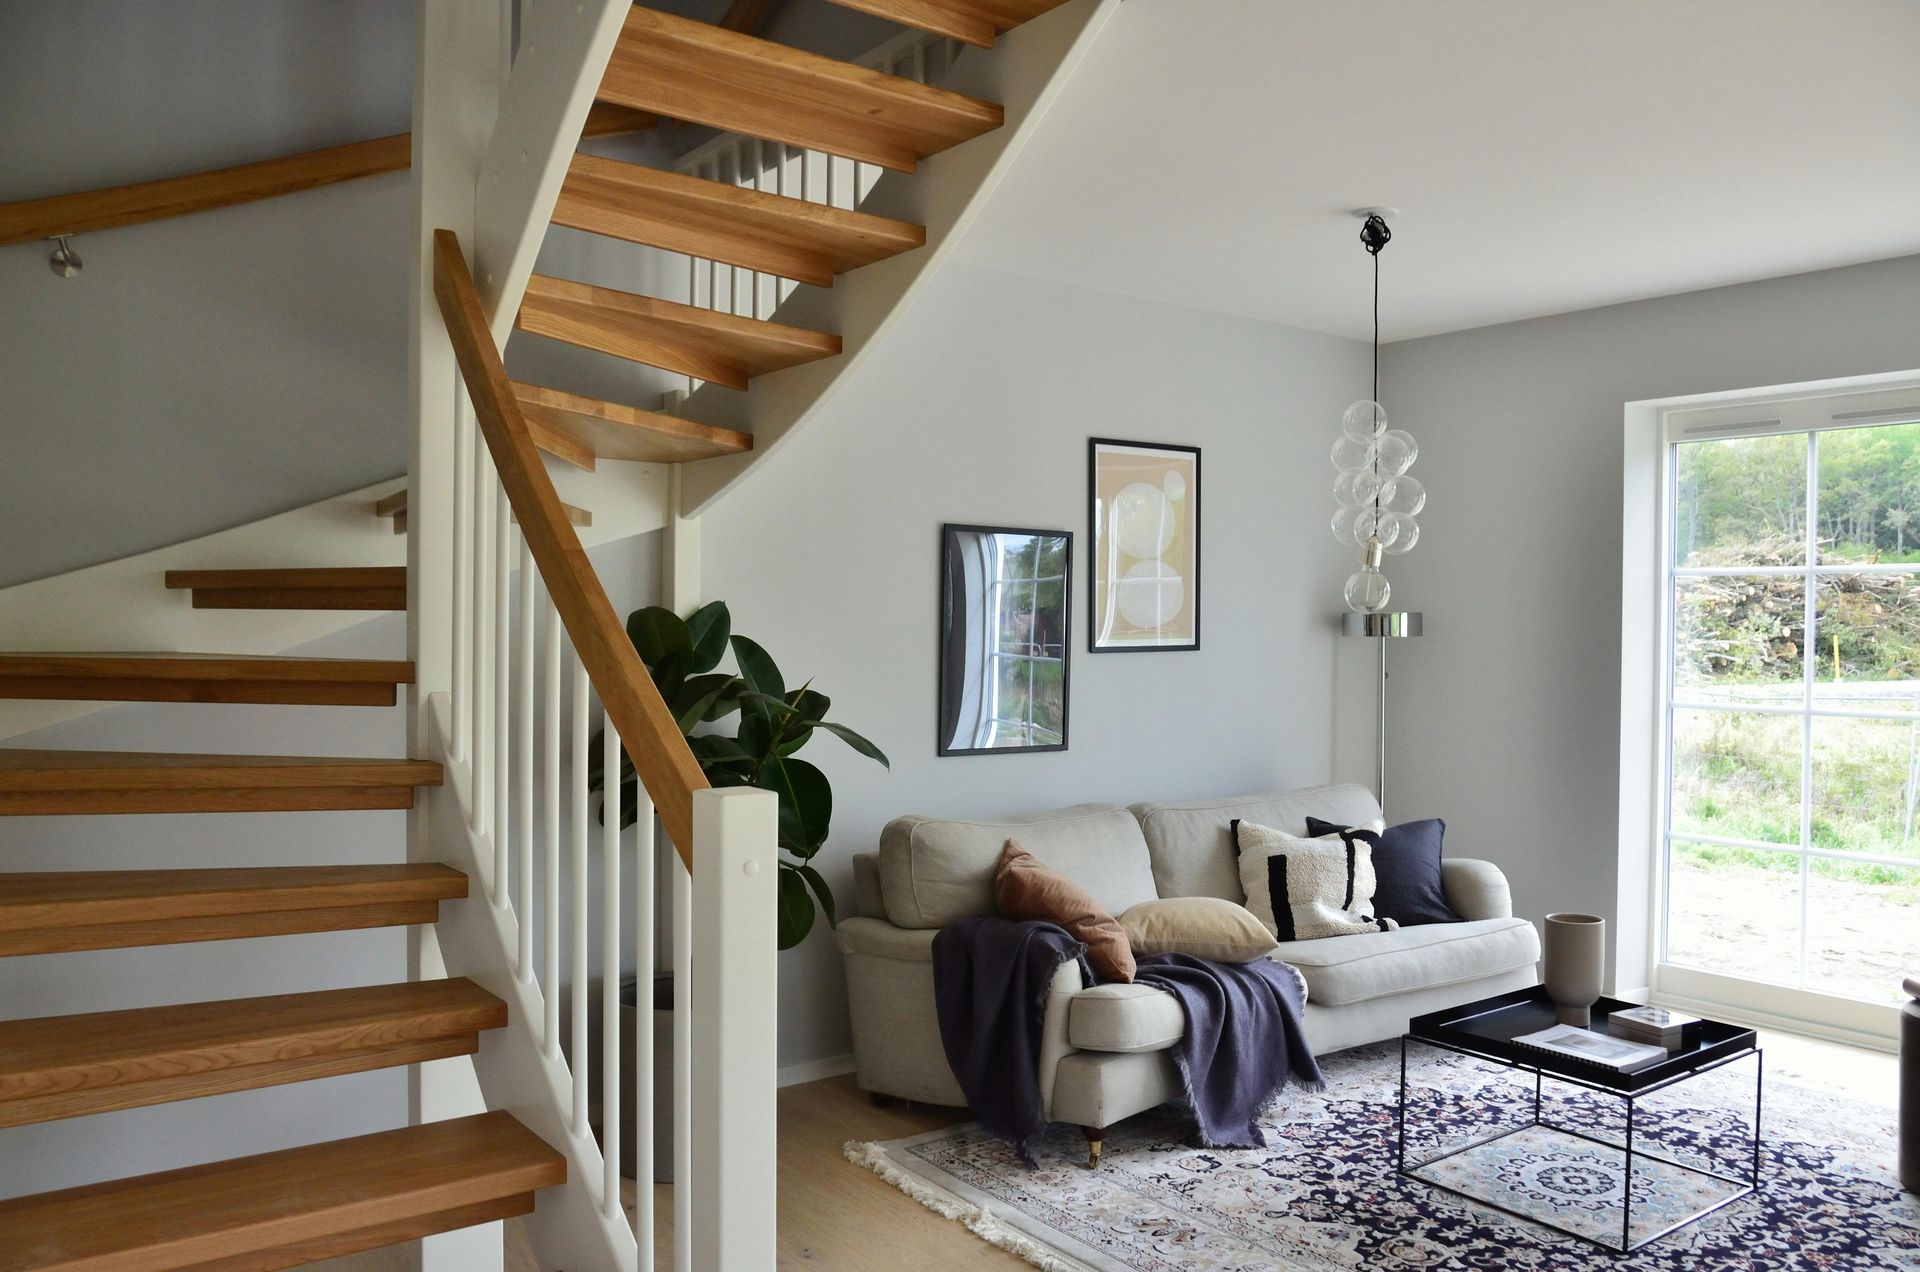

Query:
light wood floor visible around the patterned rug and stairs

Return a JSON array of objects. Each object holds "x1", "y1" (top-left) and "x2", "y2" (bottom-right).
[{"x1": 303, "y1": 1030, "x2": 1897, "y2": 1272}]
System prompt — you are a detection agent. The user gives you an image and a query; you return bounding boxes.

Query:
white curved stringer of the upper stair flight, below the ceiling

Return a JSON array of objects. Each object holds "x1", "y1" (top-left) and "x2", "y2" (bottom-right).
[{"x1": 676, "y1": 0, "x2": 1121, "y2": 517}]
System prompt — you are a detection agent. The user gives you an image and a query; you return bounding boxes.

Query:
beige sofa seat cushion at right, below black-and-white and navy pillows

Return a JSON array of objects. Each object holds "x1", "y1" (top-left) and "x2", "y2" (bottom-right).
[{"x1": 1271, "y1": 918, "x2": 1540, "y2": 1007}]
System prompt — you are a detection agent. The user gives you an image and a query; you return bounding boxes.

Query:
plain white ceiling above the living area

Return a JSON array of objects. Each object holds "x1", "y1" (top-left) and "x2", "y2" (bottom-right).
[{"x1": 960, "y1": 0, "x2": 1920, "y2": 340}]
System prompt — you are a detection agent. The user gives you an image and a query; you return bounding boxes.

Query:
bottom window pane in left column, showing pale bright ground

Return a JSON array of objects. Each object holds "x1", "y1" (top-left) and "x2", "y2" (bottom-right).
[{"x1": 1667, "y1": 844, "x2": 1799, "y2": 984}]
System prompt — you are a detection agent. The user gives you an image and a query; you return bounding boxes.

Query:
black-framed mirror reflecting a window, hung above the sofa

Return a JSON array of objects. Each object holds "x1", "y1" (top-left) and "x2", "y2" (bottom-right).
[{"x1": 939, "y1": 525, "x2": 1073, "y2": 755}]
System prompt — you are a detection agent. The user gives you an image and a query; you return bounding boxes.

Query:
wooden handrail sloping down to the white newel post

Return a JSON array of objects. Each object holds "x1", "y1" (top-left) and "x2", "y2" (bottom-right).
[{"x1": 434, "y1": 231, "x2": 707, "y2": 870}]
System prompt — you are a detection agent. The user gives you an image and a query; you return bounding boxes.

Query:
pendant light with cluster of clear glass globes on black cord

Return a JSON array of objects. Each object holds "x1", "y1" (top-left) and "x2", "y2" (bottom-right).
[{"x1": 1332, "y1": 208, "x2": 1427, "y2": 613}]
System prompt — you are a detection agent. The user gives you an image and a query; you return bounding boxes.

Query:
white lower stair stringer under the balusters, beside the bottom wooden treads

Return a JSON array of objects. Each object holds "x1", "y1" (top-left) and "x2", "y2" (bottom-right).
[{"x1": 409, "y1": 694, "x2": 651, "y2": 1272}]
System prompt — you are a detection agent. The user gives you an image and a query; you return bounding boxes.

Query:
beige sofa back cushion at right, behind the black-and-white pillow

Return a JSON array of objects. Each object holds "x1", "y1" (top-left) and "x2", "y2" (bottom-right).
[{"x1": 1131, "y1": 782, "x2": 1380, "y2": 905}]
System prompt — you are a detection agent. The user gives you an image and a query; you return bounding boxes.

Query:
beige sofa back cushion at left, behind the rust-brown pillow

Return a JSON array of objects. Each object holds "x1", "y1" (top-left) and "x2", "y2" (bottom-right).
[{"x1": 879, "y1": 803, "x2": 1158, "y2": 928}]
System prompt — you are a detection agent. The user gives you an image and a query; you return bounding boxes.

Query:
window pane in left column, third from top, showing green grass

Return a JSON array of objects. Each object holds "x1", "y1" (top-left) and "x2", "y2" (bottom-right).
[{"x1": 1670, "y1": 711, "x2": 1801, "y2": 847}]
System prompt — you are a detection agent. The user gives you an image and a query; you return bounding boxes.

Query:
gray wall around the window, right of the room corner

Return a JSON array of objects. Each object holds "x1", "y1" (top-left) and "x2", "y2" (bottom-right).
[{"x1": 1380, "y1": 257, "x2": 1920, "y2": 988}]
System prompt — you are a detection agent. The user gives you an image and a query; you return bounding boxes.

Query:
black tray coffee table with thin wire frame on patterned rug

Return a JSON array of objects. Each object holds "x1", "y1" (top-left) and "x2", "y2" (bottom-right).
[{"x1": 1396, "y1": 986, "x2": 1761, "y2": 1255}]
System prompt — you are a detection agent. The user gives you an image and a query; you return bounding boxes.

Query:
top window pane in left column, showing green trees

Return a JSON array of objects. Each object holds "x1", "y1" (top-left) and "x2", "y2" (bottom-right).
[{"x1": 1674, "y1": 432, "x2": 1807, "y2": 565}]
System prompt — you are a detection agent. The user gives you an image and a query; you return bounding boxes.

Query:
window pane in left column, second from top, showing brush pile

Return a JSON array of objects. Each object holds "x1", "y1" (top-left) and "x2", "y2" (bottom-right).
[{"x1": 1674, "y1": 575, "x2": 1807, "y2": 707}]
